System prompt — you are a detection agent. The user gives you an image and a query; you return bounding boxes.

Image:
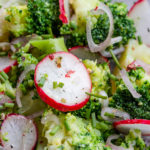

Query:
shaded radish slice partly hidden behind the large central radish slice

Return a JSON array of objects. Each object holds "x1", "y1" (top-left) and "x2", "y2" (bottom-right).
[{"x1": 68, "y1": 46, "x2": 108, "y2": 63}]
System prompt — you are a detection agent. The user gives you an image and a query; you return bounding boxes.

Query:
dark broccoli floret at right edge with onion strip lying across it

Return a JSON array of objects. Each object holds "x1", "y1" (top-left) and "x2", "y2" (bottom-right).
[{"x1": 110, "y1": 67, "x2": 150, "y2": 119}]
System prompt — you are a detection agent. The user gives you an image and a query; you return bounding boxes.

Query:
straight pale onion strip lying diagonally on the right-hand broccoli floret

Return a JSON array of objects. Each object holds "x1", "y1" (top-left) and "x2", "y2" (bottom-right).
[{"x1": 120, "y1": 69, "x2": 141, "y2": 98}]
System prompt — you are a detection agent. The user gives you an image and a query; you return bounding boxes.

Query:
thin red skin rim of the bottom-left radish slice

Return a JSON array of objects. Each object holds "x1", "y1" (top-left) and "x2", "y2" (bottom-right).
[{"x1": 0, "y1": 114, "x2": 38, "y2": 150}]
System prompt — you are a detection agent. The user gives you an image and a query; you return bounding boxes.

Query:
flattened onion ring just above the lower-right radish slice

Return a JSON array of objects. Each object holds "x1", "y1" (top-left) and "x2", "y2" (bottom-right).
[{"x1": 101, "y1": 107, "x2": 130, "y2": 122}]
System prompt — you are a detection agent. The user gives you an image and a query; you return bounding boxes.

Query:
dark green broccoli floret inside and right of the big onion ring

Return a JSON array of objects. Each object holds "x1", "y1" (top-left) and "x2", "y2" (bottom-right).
[{"x1": 92, "y1": 2, "x2": 136, "y2": 46}]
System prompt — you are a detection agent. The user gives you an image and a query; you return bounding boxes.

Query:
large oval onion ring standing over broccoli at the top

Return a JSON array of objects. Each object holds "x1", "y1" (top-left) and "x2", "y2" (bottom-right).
[{"x1": 86, "y1": 2, "x2": 114, "y2": 52}]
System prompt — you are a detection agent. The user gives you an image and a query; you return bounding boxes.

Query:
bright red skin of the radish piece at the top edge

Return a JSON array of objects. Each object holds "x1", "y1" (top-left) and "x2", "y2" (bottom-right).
[{"x1": 59, "y1": 0, "x2": 68, "y2": 24}]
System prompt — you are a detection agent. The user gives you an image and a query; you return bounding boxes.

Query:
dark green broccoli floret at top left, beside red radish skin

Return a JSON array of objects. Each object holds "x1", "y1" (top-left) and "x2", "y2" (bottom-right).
[{"x1": 27, "y1": 0, "x2": 61, "y2": 35}]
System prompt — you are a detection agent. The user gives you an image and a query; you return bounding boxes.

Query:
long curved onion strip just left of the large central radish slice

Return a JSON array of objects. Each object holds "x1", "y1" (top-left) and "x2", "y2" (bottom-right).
[{"x1": 16, "y1": 64, "x2": 35, "y2": 108}]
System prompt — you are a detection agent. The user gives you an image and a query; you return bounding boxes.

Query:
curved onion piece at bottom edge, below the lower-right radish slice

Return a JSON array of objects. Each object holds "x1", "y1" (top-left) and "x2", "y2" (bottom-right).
[{"x1": 106, "y1": 134, "x2": 134, "y2": 150}]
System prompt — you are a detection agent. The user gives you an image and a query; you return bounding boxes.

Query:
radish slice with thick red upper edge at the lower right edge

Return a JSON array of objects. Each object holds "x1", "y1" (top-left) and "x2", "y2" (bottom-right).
[{"x1": 114, "y1": 119, "x2": 150, "y2": 136}]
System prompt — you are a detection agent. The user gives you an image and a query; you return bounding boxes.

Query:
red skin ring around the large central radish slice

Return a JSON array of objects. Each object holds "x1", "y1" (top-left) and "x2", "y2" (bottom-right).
[{"x1": 34, "y1": 52, "x2": 92, "y2": 112}]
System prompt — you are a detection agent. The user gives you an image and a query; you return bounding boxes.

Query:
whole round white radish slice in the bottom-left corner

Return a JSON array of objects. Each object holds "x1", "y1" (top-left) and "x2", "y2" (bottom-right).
[{"x1": 1, "y1": 114, "x2": 37, "y2": 150}]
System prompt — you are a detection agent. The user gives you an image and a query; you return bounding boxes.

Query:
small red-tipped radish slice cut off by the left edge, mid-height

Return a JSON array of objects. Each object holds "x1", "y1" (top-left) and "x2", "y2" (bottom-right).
[{"x1": 0, "y1": 56, "x2": 17, "y2": 73}]
